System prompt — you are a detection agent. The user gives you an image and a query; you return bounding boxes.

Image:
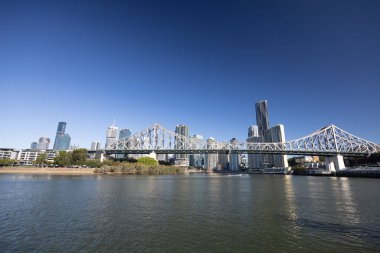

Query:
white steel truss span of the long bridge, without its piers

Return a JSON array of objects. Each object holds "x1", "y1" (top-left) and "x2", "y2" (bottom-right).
[{"x1": 105, "y1": 124, "x2": 380, "y2": 156}]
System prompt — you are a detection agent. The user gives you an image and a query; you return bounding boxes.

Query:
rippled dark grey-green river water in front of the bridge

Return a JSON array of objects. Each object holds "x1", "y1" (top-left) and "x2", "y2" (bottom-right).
[{"x1": 0, "y1": 174, "x2": 380, "y2": 252}]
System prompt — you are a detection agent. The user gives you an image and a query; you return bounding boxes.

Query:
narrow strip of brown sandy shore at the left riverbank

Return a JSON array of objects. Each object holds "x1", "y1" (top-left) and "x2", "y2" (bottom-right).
[{"x1": 0, "y1": 167, "x2": 94, "y2": 175}]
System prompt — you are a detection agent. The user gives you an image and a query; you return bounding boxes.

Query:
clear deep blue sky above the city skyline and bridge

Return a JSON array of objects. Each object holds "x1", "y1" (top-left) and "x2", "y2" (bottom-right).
[{"x1": 0, "y1": 0, "x2": 380, "y2": 148}]
